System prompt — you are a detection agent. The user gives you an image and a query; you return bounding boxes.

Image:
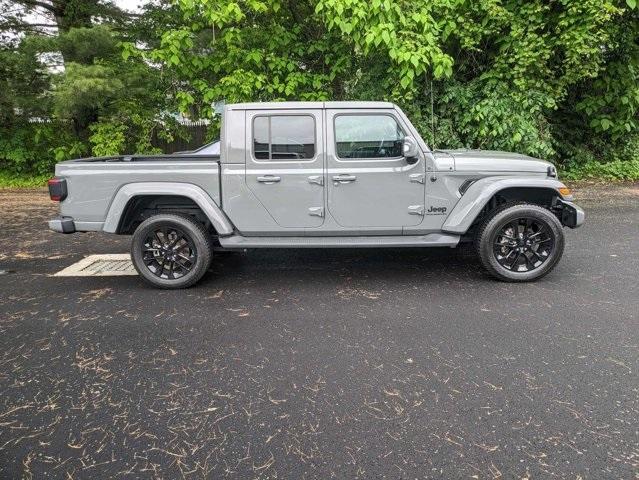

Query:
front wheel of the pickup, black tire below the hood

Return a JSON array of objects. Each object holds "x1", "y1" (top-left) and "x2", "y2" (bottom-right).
[{"x1": 475, "y1": 203, "x2": 565, "y2": 282}]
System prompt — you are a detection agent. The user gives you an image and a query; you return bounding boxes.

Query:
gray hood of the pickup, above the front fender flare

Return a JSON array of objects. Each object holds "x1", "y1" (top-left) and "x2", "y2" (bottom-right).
[{"x1": 434, "y1": 150, "x2": 552, "y2": 173}]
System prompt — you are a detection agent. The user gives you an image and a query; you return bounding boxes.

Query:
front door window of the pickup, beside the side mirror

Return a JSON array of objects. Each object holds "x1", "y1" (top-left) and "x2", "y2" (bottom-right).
[{"x1": 335, "y1": 115, "x2": 404, "y2": 158}]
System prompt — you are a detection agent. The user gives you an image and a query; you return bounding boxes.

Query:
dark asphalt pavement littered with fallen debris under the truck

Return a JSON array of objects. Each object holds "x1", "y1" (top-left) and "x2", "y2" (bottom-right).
[{"x1": 0, "y1": 185, "x2": 639, "y2": 479}]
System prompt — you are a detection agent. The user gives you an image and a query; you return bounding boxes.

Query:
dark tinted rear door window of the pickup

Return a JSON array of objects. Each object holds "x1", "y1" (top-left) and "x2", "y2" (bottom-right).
[{"x1": 253, "y1": 115, "x2": 315, "y2": 161}]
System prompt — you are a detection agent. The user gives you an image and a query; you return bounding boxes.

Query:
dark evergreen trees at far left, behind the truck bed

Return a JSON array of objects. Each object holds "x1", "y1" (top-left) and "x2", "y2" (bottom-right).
[{"x1": 0, "y1": 0, "x2": 172, "y2": 173}]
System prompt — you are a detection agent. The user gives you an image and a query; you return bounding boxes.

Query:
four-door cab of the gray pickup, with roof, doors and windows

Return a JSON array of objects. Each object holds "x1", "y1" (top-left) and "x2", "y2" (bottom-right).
[{"x1": 221, "y1": 102, "x2": 454, "y2": 236}]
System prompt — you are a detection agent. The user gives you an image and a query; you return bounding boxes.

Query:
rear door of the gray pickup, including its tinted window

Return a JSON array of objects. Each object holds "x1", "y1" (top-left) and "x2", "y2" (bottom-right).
[{"x1": 246, "y1": 110, "x2": 324, "y2": 231}]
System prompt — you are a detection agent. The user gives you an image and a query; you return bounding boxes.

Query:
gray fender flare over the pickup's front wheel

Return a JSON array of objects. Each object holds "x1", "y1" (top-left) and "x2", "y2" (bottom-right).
[{"x1": 442, "y1": 177, "x2": 565, "y2": 235}]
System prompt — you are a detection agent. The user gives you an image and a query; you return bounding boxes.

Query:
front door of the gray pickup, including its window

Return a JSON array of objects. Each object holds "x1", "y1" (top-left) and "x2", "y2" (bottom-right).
[{"x1": 326, "y1": 110, "x2": 425, "y2": 231}]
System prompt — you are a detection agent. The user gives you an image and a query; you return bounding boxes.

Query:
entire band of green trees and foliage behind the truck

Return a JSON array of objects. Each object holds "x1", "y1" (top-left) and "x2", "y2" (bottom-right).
[{"x1": 0, "y1": 0, "x2": 639, "y2": 179}]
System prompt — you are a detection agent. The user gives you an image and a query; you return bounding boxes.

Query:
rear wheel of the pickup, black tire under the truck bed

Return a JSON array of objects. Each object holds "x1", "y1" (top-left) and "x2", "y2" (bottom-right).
[{"x1": 131, "y1": 213, "x2": 213, "y2": 289}]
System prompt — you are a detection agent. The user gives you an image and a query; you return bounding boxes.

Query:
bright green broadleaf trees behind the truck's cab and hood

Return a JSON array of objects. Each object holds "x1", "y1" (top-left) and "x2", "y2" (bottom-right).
[{"x1": 141, "y1": 0, "x2": 638, "y2": 165}]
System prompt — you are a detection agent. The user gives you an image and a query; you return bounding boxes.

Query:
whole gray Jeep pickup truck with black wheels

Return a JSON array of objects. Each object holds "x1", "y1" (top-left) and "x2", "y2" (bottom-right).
[{"x1": 49, "y1": 102, "x2": 584, "y2": 288}]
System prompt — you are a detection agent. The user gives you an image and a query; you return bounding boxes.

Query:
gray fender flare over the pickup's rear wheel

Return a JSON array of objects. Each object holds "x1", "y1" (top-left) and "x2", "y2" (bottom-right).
[{"x1": 102, "y1": 182, "x2": 233, "y2": 235}]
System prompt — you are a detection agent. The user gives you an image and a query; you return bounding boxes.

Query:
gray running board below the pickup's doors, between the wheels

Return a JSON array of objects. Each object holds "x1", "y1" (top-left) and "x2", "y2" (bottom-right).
[{"x1": 218, "y1": 233, "x2": 460, "y2": 248}]
